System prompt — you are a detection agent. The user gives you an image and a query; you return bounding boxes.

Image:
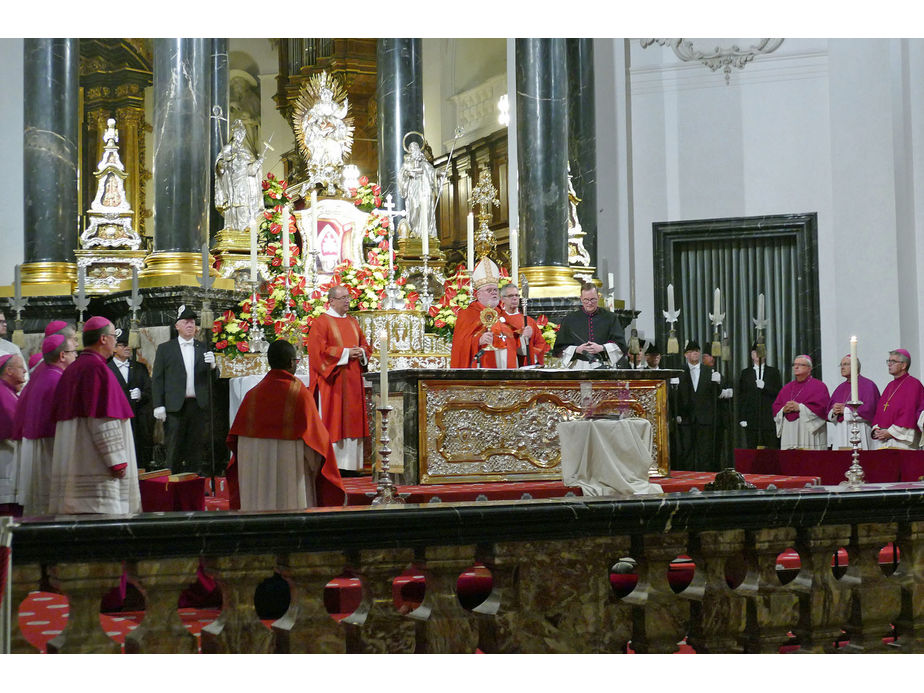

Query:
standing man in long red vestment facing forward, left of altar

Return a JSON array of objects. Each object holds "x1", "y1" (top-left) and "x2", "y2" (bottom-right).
[{"x1": 308, "y1": 285, "x2": 372, "y2": 476}]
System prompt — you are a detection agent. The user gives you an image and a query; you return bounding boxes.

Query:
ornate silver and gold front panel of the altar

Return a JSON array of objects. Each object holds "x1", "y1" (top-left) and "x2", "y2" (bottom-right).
[{"x1": 418, "y1": 380, "x2": 669, "y2": 484}]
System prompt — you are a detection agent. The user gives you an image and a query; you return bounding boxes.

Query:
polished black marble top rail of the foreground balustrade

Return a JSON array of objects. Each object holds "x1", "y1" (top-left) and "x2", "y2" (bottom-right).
[{"x1": 12, "y1": 483, "x2": 924, "y2": 564}]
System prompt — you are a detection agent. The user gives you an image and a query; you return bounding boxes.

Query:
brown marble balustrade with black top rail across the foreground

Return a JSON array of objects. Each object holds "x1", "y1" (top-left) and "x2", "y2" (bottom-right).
[{"x1": 11, "y1": 485, "x2": 924, "y2": 653}]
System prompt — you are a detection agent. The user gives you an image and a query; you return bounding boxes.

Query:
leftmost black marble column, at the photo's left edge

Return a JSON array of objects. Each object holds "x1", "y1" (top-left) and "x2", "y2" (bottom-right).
[{"x1": 23, "y1": 38, "x2": 78, "y2": 274}]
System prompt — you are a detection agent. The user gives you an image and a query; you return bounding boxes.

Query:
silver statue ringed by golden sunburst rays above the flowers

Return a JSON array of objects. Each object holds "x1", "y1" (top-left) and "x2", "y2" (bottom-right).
[{"x1": 292, "y1": 72, "x2": 353, "y2": 195}]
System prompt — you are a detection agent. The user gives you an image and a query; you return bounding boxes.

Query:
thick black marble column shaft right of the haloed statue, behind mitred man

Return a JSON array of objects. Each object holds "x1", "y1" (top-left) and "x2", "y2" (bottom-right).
[{"x1": 516, "y1": 38, "x2": 568, "y2": 270}]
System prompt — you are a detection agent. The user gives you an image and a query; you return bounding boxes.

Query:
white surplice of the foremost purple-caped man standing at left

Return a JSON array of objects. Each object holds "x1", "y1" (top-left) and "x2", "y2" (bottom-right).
[{"x1": 49, "y1": 418, "x2": 141, "y2": 515}]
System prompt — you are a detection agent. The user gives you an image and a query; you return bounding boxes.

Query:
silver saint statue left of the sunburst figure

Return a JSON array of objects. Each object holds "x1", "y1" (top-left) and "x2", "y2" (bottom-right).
[{"x1": 215, "y1": 120, "x2": 263, "y2": 231}]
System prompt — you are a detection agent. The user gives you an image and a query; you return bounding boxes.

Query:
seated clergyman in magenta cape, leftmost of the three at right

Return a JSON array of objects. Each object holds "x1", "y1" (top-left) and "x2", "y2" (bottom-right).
[{"x1": 771, "y1": 354, "x2": 830, "y2": 450}]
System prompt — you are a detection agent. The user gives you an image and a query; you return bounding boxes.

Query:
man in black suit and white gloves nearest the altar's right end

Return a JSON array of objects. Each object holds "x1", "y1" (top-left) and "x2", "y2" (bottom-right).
[{"x1": 677, "y1": 340, "x2": 722, "y2": 472}]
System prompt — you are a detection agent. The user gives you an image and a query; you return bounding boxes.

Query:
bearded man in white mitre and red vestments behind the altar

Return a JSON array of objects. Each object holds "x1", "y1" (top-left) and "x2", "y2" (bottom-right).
[{"x1": 449, "y1": 257, "x2": 517, "y2": 368}]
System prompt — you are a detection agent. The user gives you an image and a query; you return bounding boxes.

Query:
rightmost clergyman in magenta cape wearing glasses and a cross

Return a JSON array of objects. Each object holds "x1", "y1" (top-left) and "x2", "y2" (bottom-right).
[{"x1": 873, "y1": 349, "x2": 924, "y2": 450}]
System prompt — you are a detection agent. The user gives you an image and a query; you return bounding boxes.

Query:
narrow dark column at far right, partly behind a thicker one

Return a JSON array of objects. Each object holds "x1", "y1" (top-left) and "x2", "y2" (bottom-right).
[{"x1": 566, "y1": 38, "x2": 597, "y2": 267}]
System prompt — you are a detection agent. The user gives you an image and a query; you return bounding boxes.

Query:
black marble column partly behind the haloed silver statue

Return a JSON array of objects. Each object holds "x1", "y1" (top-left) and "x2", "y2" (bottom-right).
[{"x1": 376, "y1": 38, "x2": 423, "y2": 214}]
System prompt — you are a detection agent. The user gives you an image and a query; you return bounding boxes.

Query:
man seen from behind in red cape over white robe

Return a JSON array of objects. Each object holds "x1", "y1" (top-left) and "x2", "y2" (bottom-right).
[{"x1": 228, "y1": 339, "x2": 345, "y2": 510}]
